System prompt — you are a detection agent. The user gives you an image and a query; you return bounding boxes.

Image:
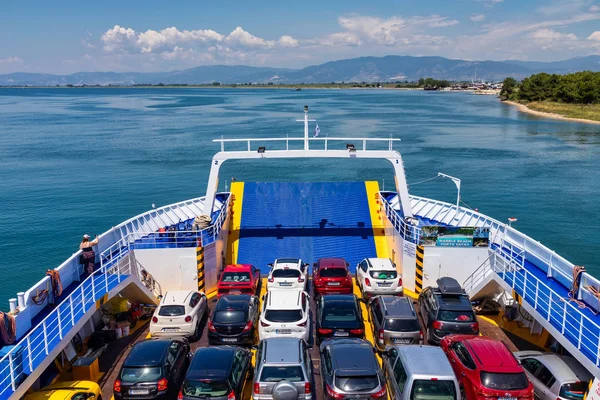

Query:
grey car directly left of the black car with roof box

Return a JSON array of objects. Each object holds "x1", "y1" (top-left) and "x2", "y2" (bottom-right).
[{"x1": 369, "y1": 296, "x2": 423, "y2": 350}]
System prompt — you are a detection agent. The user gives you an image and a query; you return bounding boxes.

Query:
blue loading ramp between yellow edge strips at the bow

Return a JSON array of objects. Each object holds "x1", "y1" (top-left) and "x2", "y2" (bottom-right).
[{"x1": 237, "y1": 182, "x2": 377, "y2": 273}]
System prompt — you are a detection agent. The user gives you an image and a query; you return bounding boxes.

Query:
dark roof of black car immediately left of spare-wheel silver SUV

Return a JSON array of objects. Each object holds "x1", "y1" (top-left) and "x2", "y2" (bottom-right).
[{"x1": 185, "y1": 346, "x2": 236, "y2": 380}]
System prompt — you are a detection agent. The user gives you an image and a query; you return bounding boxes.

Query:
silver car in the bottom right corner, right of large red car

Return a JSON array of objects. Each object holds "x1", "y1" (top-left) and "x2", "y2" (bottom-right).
[{"x1": 514, "y1": 351, "x2": 594, "y2": 400}]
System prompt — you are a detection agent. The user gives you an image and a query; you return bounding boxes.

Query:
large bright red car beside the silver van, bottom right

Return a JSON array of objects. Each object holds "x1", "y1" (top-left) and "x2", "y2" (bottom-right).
[{"x1": 440, "y1": 335, "x2": 533, "y2": 400}]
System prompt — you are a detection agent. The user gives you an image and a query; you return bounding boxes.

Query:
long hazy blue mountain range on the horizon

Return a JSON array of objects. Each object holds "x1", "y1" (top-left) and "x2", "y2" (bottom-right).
[{"x1": 0, "y1": 56, "x2": 600, "y2": 86}]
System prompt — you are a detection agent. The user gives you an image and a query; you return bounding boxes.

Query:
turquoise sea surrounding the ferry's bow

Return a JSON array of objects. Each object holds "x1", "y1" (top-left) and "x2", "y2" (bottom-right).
[{"x1": 0, "y1": 88, "x2": 600, "y2": 309}]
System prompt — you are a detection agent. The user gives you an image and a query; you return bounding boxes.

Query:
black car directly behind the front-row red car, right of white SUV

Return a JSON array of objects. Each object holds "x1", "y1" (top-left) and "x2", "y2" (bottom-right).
[{"x1": 317, "y1": 294, "x2": 365, "y2": 343}]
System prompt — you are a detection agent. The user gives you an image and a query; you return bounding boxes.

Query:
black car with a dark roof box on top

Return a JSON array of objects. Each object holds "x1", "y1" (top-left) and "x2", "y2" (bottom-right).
[{"x1": 418, "y1": 277, "x2": 479, "y2": 344}]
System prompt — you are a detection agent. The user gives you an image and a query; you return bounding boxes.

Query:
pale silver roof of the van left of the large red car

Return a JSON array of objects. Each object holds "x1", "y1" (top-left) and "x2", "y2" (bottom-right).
[{"x1": 398, "y1": 345, "x2": 455, "y2": 378}]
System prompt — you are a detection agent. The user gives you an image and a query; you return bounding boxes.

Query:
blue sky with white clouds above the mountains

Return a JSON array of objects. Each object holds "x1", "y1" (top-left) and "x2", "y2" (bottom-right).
[{"x1": 0, "y1": 0, "x2": 600, "y2": 74}]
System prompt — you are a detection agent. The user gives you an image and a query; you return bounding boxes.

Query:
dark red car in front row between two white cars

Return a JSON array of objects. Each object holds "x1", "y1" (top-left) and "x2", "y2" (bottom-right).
[{"x1": 313, "y1": 258, "x2": 352, "y2": 296}]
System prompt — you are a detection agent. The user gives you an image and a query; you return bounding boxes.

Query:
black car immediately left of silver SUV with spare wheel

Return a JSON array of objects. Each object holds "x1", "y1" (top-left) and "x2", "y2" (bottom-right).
[{"x1": 178, "y1": 346, "x2": 253, "y2": 400}]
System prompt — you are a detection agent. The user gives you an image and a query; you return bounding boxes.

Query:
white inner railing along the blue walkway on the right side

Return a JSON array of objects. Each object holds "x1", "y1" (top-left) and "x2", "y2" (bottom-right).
[{"x1": 491, "y1": 248, "x2": 600, "y2": 367}]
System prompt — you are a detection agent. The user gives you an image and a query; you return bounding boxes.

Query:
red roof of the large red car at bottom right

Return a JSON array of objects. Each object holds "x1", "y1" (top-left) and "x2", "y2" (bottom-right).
[{"x1": 462, "y1": 335, "x2": 523, "y2": 373}]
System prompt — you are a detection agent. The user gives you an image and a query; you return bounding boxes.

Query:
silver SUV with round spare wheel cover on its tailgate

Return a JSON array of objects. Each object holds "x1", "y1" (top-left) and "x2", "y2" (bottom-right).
[{"x1": 252, "y1": 338, "x2": 314, "y2": 400}]
